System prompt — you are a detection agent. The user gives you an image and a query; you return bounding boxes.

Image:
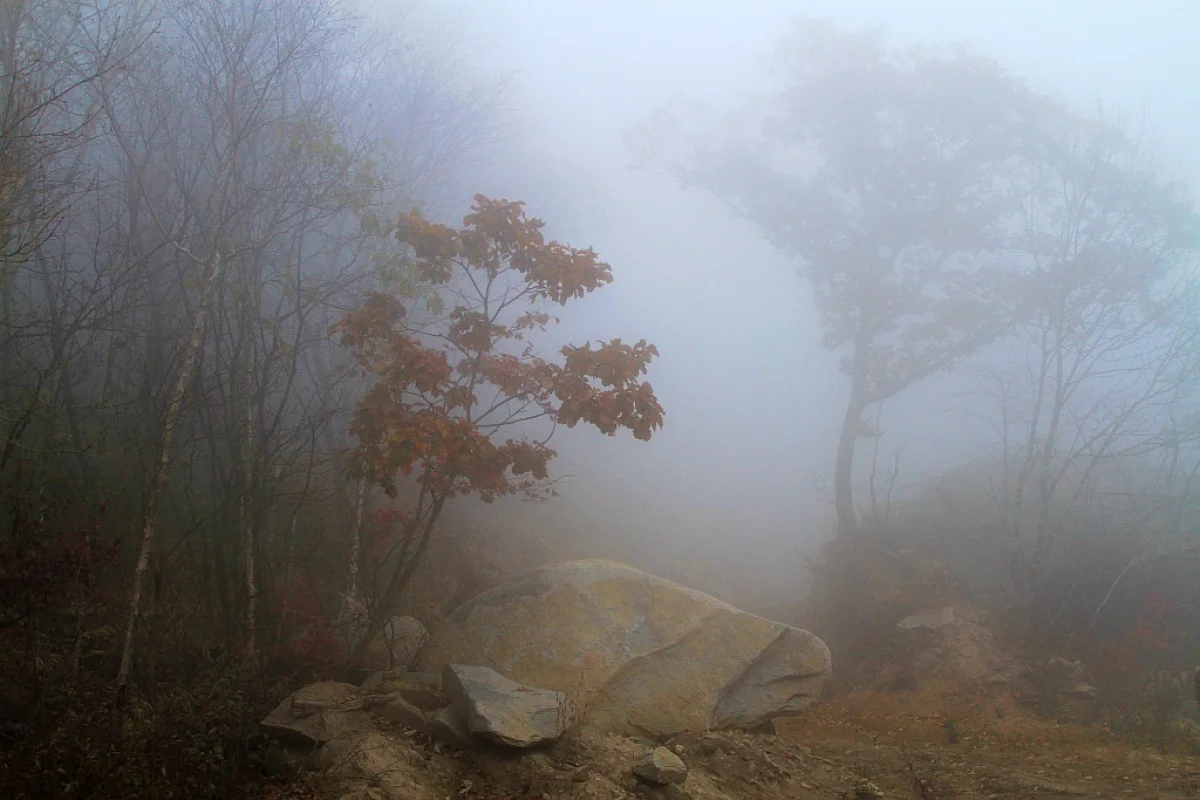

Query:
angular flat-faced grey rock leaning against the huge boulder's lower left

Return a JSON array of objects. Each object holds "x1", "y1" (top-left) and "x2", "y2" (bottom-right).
[{"x1": 442, "y1": 664, "x2": 569, "y2": 747}]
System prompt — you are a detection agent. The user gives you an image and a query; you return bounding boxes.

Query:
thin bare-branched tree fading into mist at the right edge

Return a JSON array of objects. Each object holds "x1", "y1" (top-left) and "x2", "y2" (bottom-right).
[{"x1": 964, "y1": 108, "x2": 1200, "y2": 623}]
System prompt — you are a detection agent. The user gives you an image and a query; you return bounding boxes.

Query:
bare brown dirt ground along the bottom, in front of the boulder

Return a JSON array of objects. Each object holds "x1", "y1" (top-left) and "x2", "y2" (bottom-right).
[{"x1": 276, "y1": 692, "x2": 1200, "y2": 800}]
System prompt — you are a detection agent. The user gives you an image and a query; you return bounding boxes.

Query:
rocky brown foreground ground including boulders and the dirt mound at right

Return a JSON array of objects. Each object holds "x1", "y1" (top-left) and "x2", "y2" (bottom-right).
[{"x1": 255, "y1": 561, "x2": 1200, "y2": 800}]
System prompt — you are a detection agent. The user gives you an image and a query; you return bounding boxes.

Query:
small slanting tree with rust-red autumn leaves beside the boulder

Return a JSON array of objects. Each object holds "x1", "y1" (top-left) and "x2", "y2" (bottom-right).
[{"x1": 336, "y1": 196, "x2": 664, "y2": 661}]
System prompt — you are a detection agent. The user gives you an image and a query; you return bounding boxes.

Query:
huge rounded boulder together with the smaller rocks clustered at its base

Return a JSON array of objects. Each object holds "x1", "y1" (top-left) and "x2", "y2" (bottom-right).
[{"x1": 255, "y1": 560, "x2": 830, "y2": 800}]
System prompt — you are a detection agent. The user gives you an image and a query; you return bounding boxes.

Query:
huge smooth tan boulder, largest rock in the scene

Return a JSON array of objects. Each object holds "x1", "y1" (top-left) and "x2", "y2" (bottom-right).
[{"x1": 420, "y1": 559, "x2": 830, "y2": 736}]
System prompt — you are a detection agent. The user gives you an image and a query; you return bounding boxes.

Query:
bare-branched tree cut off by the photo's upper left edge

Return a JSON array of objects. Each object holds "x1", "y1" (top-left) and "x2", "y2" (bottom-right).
[{"x1": 0, "y1": 0, "x2": 142, "y2": 482}]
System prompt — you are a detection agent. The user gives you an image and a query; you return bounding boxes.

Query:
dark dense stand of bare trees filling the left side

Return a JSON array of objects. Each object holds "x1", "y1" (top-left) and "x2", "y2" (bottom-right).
[{"x1": 0, "y1": 0, "x2": 504, "y2": 798}]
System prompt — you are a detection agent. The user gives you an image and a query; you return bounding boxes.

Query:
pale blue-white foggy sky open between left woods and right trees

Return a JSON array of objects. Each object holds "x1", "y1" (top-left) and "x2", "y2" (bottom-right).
[{"x1": 405, "y1": 0, "x2": 1200, "y2": 573}]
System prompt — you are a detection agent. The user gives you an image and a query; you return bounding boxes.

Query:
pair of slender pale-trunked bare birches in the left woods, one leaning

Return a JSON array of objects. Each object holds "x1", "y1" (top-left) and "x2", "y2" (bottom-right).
[{"x1": 97, "y1": 0, "x2": 376, "y2": 710}]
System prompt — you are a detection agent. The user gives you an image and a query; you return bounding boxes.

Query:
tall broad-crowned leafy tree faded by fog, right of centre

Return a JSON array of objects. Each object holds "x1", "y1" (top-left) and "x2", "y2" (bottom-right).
[{"x1": 635, "y1": 20, "x2": 1038, "y2": 535}]
